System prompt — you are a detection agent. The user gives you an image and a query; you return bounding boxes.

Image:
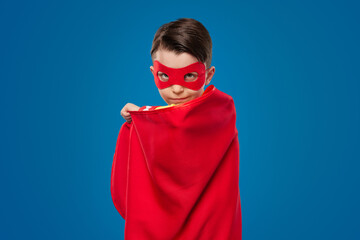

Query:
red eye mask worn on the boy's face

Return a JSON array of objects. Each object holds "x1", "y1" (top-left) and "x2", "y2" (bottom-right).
[{"x1": 154, "y1": 60, "x2": 206, "y2": 91}]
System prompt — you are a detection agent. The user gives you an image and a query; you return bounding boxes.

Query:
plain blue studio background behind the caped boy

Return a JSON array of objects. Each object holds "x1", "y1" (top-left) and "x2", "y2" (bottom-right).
[{"x1": 0, "y1": 0, "x2": 360, "y2": 240}]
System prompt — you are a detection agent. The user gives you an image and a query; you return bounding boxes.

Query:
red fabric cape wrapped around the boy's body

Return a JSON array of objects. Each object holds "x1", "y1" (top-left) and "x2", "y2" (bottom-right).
[{"x1": 111, "y1": 85, "x2": 242, "y2": 240}]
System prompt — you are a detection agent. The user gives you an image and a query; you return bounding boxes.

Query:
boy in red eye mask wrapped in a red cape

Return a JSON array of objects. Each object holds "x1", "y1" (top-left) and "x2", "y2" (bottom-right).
[{"x1": 111, "y1": 18, "x2": 242, "y2": 240}]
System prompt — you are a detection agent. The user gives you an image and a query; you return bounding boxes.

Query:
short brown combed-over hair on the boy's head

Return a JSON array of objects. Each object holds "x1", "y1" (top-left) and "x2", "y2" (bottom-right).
[{"x1": 150, "y1": 18, "x2": 212, "y2": 68}]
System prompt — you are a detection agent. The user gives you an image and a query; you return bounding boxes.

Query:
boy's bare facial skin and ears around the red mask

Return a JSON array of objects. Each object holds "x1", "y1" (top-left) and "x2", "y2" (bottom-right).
[{"x1": 150, "y1": 49, "x2": 215, "y2": 105}]
